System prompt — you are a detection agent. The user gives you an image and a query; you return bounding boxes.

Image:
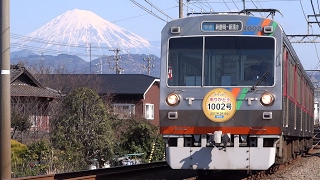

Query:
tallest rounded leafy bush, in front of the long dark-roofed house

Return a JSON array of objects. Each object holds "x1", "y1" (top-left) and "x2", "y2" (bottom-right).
[{"x1": 51, "y1": 88, "x2": 114, "y2": 172}]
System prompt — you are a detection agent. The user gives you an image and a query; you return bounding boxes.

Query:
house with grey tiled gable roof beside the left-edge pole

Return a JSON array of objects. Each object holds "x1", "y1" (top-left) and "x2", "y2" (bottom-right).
[{"x1": 10, "y1": 64, "x2": 61, "y2": 134}]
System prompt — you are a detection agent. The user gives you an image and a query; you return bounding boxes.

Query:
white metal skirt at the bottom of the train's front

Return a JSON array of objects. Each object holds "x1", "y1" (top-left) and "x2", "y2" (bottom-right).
[{"x1": 165, "y1": 135, "x2": 276, "y2": 170}]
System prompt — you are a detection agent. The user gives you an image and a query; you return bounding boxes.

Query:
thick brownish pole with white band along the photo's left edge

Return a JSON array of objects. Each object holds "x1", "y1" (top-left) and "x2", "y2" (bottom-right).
[{"x1": 0, "y1": 0, "x2": 11, "y2": 180}]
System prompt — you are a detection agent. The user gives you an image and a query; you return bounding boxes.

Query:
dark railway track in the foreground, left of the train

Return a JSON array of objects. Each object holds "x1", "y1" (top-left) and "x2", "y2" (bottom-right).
[{"x1": 11, "y1": 161, "x2": 196, "y2": 180}]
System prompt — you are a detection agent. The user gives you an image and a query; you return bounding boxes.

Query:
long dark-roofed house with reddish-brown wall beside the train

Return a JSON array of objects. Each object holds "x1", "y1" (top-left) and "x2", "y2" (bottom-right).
[{"x1": 37, "y1": 74, "x2": 160, "y2": 125}]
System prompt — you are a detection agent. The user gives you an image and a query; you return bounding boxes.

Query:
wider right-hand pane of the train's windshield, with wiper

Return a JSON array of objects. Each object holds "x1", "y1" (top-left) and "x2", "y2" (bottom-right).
[{"x1": 204, "y1": 36, "x2": 275, "y2": 86}]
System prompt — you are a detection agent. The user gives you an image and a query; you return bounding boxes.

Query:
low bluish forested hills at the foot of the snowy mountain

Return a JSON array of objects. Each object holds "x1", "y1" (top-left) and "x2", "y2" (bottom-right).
[{"x1": 10, "y1": 51, "x2": 160, "y2": 77}]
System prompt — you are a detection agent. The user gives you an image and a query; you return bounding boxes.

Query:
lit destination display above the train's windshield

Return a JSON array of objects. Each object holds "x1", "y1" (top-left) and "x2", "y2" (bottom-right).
[{"x1": 201, "y1": 21, "x2": 242, "y2": 32}]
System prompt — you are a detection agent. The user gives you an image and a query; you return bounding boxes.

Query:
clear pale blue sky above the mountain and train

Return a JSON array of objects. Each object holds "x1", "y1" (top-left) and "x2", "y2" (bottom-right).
[{"x1": 10, "y1": 0, "x2": 320, "y2": 70}]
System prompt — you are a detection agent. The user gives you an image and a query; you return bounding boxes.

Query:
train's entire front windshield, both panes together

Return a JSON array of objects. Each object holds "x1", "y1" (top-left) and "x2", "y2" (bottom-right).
[{"x1": 168, "y1": 36, "x2": 275, "y2": 86}]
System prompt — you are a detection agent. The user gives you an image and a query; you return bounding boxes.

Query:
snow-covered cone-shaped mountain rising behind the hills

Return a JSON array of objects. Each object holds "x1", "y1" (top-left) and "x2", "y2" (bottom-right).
[{"x1": 12, "y1": 9, "x2": 159, "y2": 57}]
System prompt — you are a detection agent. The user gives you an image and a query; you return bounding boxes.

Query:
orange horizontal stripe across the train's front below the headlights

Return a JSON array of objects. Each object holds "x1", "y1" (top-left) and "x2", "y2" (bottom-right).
[{"x1": 160, "y1": 126, "x2": 281, "y2": 134}]
